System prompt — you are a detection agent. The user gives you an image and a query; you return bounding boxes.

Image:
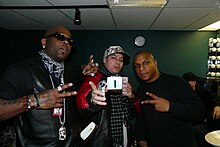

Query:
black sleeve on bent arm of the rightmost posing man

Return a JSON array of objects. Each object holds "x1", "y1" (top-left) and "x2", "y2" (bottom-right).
[{"x1": 169, "y1": 79, "x2": 205, "y2": 123}]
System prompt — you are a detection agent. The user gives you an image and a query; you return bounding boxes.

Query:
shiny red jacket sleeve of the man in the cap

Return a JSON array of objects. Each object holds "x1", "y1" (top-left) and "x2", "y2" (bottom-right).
[{"x1": 76, "y1": 72, "x2": 102, "y2": 110}]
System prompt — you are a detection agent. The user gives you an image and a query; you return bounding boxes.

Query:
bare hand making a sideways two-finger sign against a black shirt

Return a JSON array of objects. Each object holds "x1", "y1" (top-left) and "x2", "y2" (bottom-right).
[{"x1": 141, "y1": 92, "x2": 170, "y2": 112}]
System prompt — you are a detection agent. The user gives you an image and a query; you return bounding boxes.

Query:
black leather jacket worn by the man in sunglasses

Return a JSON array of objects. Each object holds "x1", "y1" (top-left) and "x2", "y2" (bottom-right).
[{"x1": 0, "y1": 57, "x2": 81, "y2": 147}]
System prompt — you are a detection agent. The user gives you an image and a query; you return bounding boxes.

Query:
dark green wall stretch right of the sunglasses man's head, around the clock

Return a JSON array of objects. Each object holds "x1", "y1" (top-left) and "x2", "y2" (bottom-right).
[{"x1": 72, "y1": 31, "x2": 216, "y2": 87}]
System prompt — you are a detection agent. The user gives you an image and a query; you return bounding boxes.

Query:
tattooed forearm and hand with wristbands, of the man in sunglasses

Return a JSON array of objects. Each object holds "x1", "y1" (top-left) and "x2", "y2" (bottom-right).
[{"x1": 0, "y1": 83, "x2": 77, "y2": 122}]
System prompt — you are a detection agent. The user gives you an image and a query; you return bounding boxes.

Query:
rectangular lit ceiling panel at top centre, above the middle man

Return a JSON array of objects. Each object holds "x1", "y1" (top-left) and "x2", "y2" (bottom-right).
[{"x1": 108, "y1": 0, "x2": 167, "y2": 8}]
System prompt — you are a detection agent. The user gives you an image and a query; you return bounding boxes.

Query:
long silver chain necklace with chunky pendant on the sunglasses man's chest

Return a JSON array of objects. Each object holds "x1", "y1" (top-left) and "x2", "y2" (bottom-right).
[{"x1": 49, "y1": 75, "x2": 66, "y2": 140}]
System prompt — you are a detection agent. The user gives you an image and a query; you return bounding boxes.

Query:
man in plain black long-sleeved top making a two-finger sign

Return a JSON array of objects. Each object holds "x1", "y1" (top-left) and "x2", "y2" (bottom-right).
[{"x1": 133, "y1": 50, "x2": 204, "y2": 147}]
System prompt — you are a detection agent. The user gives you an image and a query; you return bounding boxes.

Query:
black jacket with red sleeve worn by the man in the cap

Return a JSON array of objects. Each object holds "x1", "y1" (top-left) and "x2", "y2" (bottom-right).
[{"x1": 77, "y1": 72, "x2": 136, "y2": 147}]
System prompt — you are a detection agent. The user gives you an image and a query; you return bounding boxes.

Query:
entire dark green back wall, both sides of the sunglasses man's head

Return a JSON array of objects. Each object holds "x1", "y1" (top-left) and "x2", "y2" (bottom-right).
[{"x1": 0, "y1": 29, "x2": 220, "y2": 89}]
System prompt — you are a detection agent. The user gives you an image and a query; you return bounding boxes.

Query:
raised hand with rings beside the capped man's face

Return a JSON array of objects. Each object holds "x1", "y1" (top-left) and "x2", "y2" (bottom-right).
[{"x1": 81, "y1": 55, "x2": 98, "y2": 77}]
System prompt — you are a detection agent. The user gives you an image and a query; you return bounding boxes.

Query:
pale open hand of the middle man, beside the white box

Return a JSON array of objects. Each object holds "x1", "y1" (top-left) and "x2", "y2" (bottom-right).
[{"x1": 89, "y1": 82, "x2": 107, "y2": 106}]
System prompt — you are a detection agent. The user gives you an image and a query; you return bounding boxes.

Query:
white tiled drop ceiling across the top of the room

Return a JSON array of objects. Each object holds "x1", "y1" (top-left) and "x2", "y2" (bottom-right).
[{"x1": 0, "y1": 0, "x2": 220, "y2": 31}]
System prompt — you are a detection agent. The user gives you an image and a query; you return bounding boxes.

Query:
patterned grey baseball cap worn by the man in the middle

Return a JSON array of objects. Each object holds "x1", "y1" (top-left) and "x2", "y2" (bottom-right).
[{"x1": 103, "y1": 46, "x2": 130, "y2": 64}]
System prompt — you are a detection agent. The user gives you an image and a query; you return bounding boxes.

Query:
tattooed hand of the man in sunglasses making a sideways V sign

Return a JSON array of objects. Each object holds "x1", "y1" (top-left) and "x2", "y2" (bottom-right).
[{"x1": 37, "y1": 83, "x2": 77, "y2": 109}]
